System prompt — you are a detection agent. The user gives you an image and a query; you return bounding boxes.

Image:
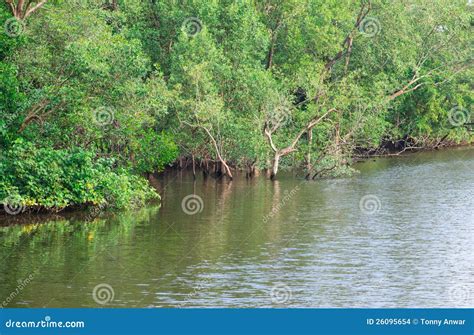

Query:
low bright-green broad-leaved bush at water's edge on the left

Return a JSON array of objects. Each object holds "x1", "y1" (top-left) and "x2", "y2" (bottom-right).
[{"x1": 0, "y1": 139, "x2": 157, "y2": 210}]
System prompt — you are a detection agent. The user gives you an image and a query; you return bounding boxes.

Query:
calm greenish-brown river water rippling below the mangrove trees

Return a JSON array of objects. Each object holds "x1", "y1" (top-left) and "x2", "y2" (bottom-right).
[{"x1": 0, "y1": 149, "x2": 474, "y2": 308}]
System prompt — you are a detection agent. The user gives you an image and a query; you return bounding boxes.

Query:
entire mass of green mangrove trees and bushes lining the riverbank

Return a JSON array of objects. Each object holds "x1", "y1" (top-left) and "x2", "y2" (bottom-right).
[{"x1": 0, "y1": 0, "x2": 474, "y2": 209}]
